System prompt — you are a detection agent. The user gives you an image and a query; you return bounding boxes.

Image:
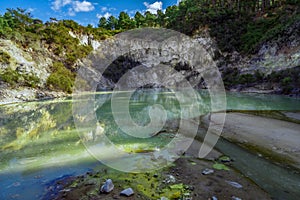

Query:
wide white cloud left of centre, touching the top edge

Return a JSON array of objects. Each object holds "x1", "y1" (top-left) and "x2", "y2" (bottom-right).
[{"x1": 51, "y1": 0, "x2": 95, "y2": 16}]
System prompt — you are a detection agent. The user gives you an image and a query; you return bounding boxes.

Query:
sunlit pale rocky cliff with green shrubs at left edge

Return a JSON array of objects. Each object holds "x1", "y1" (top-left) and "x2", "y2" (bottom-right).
[{"x1": 0, "y1": 39, "x2": 55, "y2": 103}]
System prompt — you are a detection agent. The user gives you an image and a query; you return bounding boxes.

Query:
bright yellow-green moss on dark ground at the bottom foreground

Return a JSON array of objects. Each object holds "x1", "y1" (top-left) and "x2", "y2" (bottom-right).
[{"x1": 61, "y1": 166, "x2": 190, "y2": 199}]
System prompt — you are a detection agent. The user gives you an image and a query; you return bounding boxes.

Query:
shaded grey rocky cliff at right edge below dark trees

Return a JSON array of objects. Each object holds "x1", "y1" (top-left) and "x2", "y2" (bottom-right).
[{"x1": 219, "y1": 21, "x2": 300, "y2": 96}]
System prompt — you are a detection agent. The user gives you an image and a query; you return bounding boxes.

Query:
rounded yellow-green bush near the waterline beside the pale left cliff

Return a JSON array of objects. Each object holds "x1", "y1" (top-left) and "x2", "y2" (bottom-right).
[{"x1": 47, "y1": 62, "x2": 75, "y2": 93}]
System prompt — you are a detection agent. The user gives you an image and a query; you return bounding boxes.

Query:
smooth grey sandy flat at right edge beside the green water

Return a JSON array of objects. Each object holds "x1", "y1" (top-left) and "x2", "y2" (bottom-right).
[{"x1": 203, "y1": 112, "x2": 300, "y2": 169}]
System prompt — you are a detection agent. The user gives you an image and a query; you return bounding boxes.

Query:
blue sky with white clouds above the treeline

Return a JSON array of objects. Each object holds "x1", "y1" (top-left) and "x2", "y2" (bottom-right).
[{"x1": 0, "y1": 0, "x2": 177, "y2": 25}]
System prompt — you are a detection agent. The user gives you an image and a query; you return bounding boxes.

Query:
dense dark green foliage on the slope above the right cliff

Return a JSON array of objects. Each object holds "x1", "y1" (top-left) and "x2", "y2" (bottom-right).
[{"x1": 164, "y1": 0, "x2": 300, "y2": 53}]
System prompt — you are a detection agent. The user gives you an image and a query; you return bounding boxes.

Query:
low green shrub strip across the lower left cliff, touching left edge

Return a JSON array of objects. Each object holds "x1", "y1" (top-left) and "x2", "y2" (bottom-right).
[{"x1": 0, "y1": 68, "x2": 40, "y2": 87}]
